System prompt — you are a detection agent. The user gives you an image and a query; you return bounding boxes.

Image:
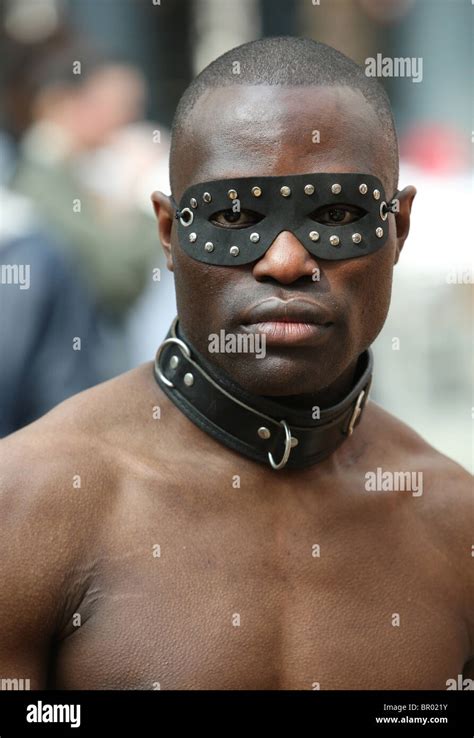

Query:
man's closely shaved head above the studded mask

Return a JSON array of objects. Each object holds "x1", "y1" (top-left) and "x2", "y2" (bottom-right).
[{"x1": 170, "y1": 37, "x2": 398, "y2": 199}]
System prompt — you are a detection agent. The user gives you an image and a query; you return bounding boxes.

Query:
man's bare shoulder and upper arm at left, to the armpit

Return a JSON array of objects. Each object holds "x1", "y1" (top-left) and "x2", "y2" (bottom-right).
[{"x1": 0, "y1": 366, "x2": 165, "y2": 652}]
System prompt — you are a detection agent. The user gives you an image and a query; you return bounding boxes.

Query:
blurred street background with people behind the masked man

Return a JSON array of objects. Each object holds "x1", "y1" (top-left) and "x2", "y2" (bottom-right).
[{"x1": 0, "y1": 0, "x2": 474, "y2": 471}]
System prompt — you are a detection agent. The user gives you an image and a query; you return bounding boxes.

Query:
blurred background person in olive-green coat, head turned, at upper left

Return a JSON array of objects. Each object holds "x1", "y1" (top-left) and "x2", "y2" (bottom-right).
[{"x1": 12, "y1": 44, "x2": 157, "y2": 376}]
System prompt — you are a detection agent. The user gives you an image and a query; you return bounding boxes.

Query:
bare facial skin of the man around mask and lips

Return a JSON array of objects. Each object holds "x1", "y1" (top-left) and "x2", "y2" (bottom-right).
[{"x1": 161, "y1": 85, "x2": 402, "y2": 406}]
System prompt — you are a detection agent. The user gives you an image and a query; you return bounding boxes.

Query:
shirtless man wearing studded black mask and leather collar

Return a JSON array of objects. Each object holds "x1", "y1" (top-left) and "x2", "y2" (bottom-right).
[{"x1": 0, "y1": 37, "x2": 474, "y2": 689}]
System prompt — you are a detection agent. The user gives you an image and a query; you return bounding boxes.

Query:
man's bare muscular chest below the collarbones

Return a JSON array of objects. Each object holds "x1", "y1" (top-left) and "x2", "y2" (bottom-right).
[{"x1": 53, "y1": 468, "x2": 466, "y2": 689}]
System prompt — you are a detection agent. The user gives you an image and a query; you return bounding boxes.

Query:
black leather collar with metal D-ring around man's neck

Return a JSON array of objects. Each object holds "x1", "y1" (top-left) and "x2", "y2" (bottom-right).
[{"x1": 154, "y1": 318, "x2": 373, "y2": 470}]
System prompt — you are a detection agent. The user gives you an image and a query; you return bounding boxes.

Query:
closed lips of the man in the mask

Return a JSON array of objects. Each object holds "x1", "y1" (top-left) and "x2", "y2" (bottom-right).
[{"x1": 242, "y1": 298, "x2": 334, "y2": 346}]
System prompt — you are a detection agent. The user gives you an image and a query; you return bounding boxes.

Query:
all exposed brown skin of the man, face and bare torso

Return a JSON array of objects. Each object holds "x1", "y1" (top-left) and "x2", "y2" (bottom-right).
[{"x1": 0, "y1": 86, "x2": 474, "y2": 690}]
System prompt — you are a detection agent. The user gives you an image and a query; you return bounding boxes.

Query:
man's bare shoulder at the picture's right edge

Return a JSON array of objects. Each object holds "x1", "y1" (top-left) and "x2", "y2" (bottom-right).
[{"x1": 365, "y1": 402, "x2": 474, "y2": 644}]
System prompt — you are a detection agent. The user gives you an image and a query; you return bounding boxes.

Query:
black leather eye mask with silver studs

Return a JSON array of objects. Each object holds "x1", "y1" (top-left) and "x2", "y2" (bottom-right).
[{"x1": 176, "y1": 173, "x2": 398, "y2": 266}]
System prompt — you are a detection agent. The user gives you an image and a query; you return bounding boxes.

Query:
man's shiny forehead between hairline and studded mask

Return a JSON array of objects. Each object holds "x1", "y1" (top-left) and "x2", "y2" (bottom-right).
[{"x1": 177, "y1": 85, "x2": 388, "y2": 195}]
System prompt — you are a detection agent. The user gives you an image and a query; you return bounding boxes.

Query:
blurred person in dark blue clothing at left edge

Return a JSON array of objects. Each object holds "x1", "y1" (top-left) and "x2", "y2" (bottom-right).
[{"x1": 0, "y1": 187, "x2": 105, "y2": 438}]
